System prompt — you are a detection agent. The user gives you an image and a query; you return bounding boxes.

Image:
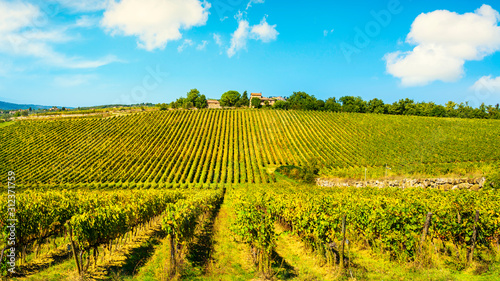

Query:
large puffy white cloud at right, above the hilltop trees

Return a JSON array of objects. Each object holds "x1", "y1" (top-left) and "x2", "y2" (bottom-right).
[{"x1": 384, "y1": 5, "x2": 500, "y2": 86}]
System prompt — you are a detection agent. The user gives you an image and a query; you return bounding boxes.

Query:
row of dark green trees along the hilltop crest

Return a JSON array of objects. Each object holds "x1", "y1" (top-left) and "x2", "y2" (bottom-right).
[{"x1": 160, "y1": 89, "x2": 500, "y2": 119}]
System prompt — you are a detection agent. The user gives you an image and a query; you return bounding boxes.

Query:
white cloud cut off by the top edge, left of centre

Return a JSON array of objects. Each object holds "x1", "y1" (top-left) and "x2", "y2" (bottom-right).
[{"x1": 101, "y1": 0, "x2": 210, "y2": 51}]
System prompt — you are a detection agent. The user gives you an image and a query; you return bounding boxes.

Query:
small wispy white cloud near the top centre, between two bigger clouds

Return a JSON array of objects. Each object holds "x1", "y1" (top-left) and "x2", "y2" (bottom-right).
[{"x1": 227, "y1": 17, "x2": 279, "y2": 57}]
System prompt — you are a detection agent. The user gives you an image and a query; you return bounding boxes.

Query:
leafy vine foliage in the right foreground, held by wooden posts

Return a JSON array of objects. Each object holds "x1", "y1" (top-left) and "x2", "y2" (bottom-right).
[{"x1": 247, "y1": 183, "x2": 500, "y2": 264}]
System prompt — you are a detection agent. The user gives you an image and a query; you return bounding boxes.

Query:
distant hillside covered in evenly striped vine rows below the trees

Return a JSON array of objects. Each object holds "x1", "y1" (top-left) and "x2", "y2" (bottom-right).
[{"x1": 0, "y1": 110, "x2": 500, "y2": 187}]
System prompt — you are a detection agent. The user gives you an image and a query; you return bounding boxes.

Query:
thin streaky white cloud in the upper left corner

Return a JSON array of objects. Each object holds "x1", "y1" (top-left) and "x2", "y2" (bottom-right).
[{"x1": 0, "y1": 0, "x2": 117, "y2": 68}]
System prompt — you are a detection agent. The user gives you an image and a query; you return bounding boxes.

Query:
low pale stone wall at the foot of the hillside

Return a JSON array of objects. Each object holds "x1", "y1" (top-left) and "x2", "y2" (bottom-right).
[{"x1": 316, "y1": 178, "x2": 486, "y2": 190}]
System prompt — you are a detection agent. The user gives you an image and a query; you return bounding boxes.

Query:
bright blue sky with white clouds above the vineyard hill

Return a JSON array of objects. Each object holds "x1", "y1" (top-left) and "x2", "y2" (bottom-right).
[{"x1": 0, "y1": 0, "x2": 500, "y2": 107}]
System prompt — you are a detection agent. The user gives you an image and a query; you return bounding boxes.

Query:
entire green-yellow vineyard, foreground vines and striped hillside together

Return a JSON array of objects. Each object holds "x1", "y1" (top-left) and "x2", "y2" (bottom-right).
[{"x1": 0, "y1": 110, "x2": 500, "y2": 280}]
